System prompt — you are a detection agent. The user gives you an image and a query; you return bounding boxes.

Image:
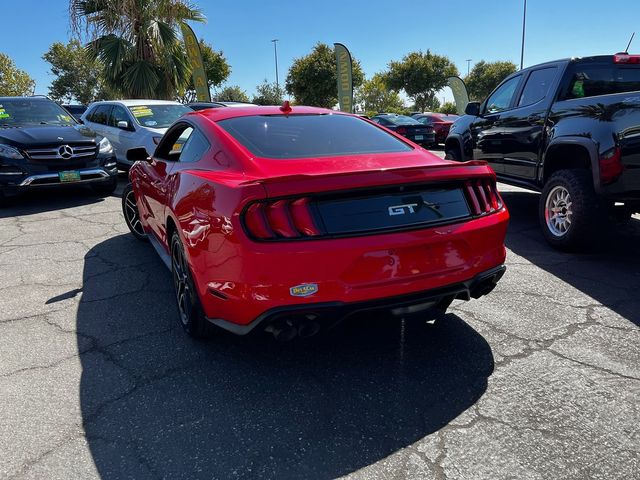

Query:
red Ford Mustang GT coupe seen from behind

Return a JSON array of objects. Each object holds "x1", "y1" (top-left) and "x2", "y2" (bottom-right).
[{"x1": 122, "y1": 104, "x2": 509, "y2": 339}]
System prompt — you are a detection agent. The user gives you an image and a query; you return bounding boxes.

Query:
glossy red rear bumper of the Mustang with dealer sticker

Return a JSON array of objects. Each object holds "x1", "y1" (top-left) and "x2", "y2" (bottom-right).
[{"x1": 189, "y1": 209, "x2": 509, "y2": 330}]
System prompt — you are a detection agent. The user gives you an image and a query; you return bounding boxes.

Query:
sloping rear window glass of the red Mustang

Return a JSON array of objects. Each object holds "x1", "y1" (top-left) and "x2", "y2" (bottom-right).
[{"x1": 218, "y1": 114, "x2": 411, "y2": 159}]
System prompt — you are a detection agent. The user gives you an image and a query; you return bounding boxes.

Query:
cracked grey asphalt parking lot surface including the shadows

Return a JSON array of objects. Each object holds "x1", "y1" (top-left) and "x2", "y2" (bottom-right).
[{"x1": 0, "y1": 160, "x2": 640, "y2": 480}]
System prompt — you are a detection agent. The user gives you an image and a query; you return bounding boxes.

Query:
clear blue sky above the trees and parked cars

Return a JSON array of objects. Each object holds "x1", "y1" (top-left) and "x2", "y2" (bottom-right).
[{"x1": 0, "y1": 0, "x2": 640, "y2": 102}]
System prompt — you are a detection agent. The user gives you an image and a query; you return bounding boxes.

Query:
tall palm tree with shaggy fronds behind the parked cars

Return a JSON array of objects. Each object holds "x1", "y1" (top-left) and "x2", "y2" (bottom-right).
[{"x1": 69, "y1": 0, "x2": 205, "y2": 99}]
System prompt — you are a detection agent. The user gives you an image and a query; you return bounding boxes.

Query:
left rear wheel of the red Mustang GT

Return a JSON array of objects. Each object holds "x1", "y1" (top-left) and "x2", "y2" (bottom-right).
[{"x1": 171, "y1": 232, "x2": 211, "y2": 338}]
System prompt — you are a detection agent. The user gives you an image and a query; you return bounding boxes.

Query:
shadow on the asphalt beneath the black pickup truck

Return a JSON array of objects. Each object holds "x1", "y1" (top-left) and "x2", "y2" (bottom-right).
[{"x1": 501, "y1": 191, "x2": 640, "y2": 326}]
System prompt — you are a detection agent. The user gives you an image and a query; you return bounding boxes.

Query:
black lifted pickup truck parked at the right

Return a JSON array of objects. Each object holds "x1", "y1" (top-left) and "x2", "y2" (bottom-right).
[{"x1": 445, "y1": 53, "x2": 640, "y2": 249}]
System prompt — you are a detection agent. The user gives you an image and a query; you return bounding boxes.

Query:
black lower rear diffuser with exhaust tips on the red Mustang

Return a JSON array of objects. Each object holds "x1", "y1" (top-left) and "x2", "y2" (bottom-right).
[{"x1": 207, "y1": 265, "x2": 506, "y2": 335}]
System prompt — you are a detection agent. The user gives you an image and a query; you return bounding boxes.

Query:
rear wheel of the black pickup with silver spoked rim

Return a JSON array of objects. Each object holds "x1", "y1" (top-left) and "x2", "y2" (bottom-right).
[{"x1": 538, "y1": 169, "x2": 608, "y2": 251}]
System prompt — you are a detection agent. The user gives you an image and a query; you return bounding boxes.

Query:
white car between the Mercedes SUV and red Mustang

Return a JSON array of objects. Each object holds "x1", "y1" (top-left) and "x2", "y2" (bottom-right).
[{"x1": 81, "y1": 100, "x2": 193, "y2": 169}]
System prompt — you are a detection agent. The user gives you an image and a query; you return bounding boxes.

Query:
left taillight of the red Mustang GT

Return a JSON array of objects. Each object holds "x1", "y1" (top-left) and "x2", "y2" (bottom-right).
[{"x1": 244, "y1": 197, "x2": 320, "y2": 240}]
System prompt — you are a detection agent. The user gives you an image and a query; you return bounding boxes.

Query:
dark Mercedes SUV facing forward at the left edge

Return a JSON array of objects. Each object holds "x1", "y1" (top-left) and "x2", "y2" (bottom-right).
[{"x1": 0, "y1": 97, "x2": 118, "y2": 201}]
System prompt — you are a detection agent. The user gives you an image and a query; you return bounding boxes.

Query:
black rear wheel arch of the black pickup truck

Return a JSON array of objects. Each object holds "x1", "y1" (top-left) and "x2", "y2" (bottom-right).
[{"x1": 538, "y1": 137, "x2": 600, "y2": 193}]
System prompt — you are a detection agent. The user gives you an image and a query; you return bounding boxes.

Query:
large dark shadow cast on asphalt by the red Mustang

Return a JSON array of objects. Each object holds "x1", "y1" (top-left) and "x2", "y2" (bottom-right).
[{"x1": 77, "y1": 235, "x2": 494, "y2": 479}]
